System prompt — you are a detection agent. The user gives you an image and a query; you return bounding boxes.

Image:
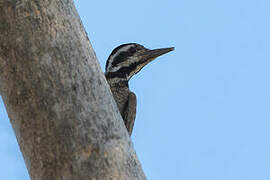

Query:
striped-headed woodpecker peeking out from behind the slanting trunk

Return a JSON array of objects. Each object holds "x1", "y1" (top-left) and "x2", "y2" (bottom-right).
[{"x1": 105, "y1": 43, "x2": 174, "y2": 136}]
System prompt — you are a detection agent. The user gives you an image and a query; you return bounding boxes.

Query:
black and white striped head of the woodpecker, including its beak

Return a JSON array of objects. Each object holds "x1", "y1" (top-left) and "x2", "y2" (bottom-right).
[{"x1": 105, "y1": 43, "x2": 174, "y2": 81}]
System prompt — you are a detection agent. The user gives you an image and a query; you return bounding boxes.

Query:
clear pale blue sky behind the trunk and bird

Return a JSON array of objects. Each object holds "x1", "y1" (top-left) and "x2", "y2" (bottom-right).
[{"x1": 0, "y1": 0, "x2": 270, "y2": 180}]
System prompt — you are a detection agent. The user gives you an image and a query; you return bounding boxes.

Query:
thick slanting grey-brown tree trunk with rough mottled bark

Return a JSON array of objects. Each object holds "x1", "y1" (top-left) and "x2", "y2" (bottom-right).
[{"x1": 0, "y1": 0, "x2": 145, "y2": 180}]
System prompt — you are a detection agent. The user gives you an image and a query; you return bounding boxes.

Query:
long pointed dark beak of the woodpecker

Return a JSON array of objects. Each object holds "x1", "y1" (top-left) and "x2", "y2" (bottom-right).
[{"x1": 142, "y1": 47, "x2": 174, "y2": 64}]
